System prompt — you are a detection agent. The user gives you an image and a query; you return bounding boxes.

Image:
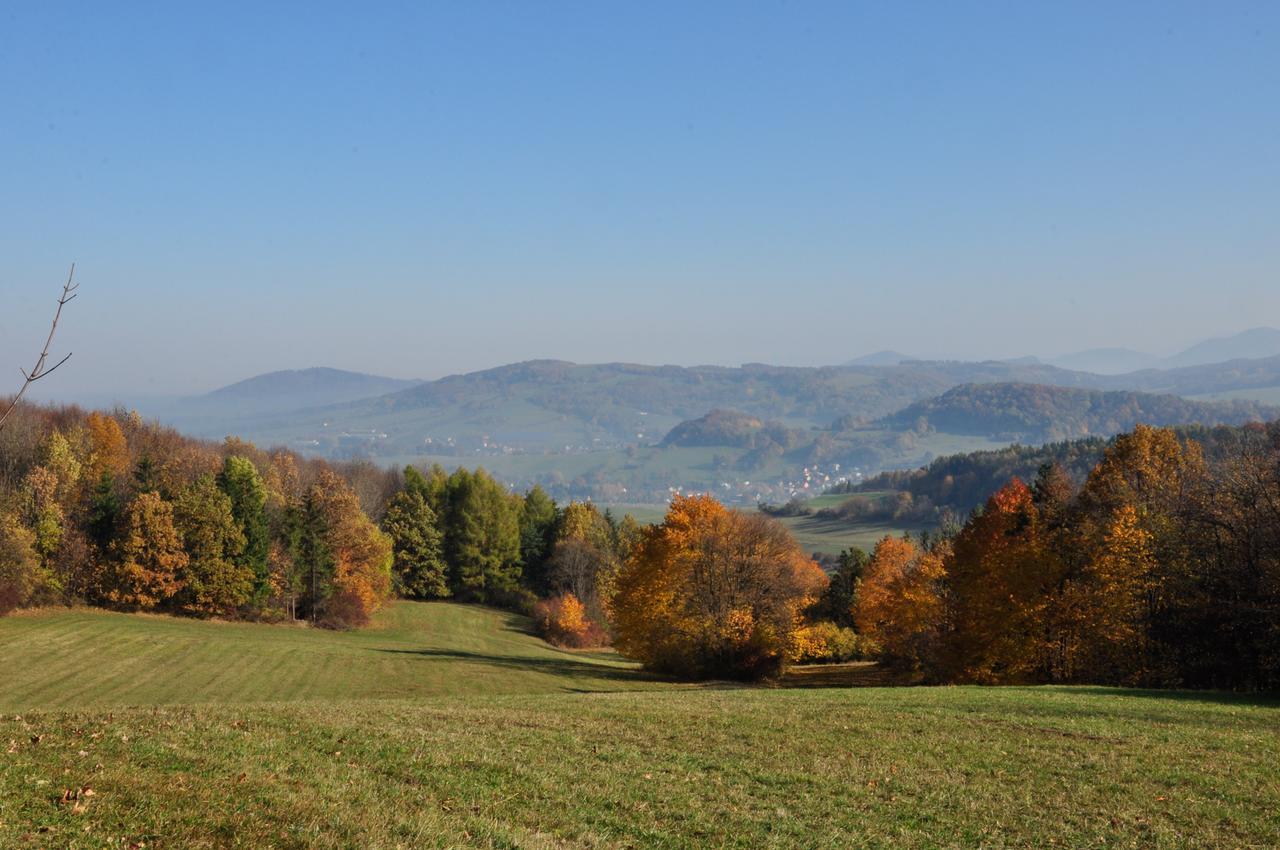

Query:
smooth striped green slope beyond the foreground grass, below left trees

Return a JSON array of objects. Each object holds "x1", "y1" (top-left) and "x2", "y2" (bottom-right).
[{"x1": 0, "y1": 602, "x2": 653, "y2": 712}]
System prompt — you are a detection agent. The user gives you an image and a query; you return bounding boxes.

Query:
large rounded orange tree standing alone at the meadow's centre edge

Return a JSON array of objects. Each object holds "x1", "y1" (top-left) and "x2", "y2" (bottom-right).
[{"x1": 611, "y1": 495, "x2": 826, "y2": 678}]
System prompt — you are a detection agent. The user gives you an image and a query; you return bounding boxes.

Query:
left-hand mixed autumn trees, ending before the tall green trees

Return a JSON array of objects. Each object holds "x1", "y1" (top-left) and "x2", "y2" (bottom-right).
[{"x1": 0, "y1": 406, "x2": 392, "y2": 627}]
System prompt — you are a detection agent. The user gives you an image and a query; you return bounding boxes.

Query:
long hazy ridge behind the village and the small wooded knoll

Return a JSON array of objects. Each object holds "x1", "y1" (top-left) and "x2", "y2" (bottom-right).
[{"x1": 165, "y1": 361, "x2": 1098, "y2": 456}]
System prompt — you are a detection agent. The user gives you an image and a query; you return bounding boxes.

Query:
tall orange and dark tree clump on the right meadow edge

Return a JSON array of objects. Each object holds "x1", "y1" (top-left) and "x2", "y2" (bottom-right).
[{"x1": 851, "y1": 424, "x2": 1280, "y2": 689}]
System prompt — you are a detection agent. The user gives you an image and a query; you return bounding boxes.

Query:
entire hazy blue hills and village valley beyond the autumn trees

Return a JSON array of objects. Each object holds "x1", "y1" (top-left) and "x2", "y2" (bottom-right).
[{"x1": 127, "y1": 345, "x2": 1280, "y2": 501}]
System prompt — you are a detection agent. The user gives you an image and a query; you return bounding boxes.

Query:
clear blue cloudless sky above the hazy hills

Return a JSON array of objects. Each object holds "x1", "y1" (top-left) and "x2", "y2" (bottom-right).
[{"x1": 0, "y1": 0, "x2": 1280, "y2": 396}]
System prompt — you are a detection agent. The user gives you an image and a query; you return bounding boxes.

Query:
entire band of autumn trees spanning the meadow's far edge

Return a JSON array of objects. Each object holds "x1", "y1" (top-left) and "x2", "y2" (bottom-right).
[{"x1": 10, "y1": 406, "x2": 1280, "y2": 689}]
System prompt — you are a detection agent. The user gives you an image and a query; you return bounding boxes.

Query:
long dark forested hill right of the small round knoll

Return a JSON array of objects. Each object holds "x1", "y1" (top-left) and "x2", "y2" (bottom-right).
[{"x1": 879, "y1": 383, "x2": 1280, "y2": 443}]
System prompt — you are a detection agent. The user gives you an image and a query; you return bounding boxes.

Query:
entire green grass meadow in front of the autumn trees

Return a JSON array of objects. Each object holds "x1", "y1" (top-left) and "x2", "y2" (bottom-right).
[{"x1": 0, "y1": 603, "x2": 1280, "y2": 849}]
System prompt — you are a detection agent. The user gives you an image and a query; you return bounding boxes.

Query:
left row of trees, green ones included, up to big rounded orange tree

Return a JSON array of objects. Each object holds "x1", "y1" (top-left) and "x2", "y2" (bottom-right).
[{"x1": 0, "y1": 405, "x2": 650, "y2": 641}]
